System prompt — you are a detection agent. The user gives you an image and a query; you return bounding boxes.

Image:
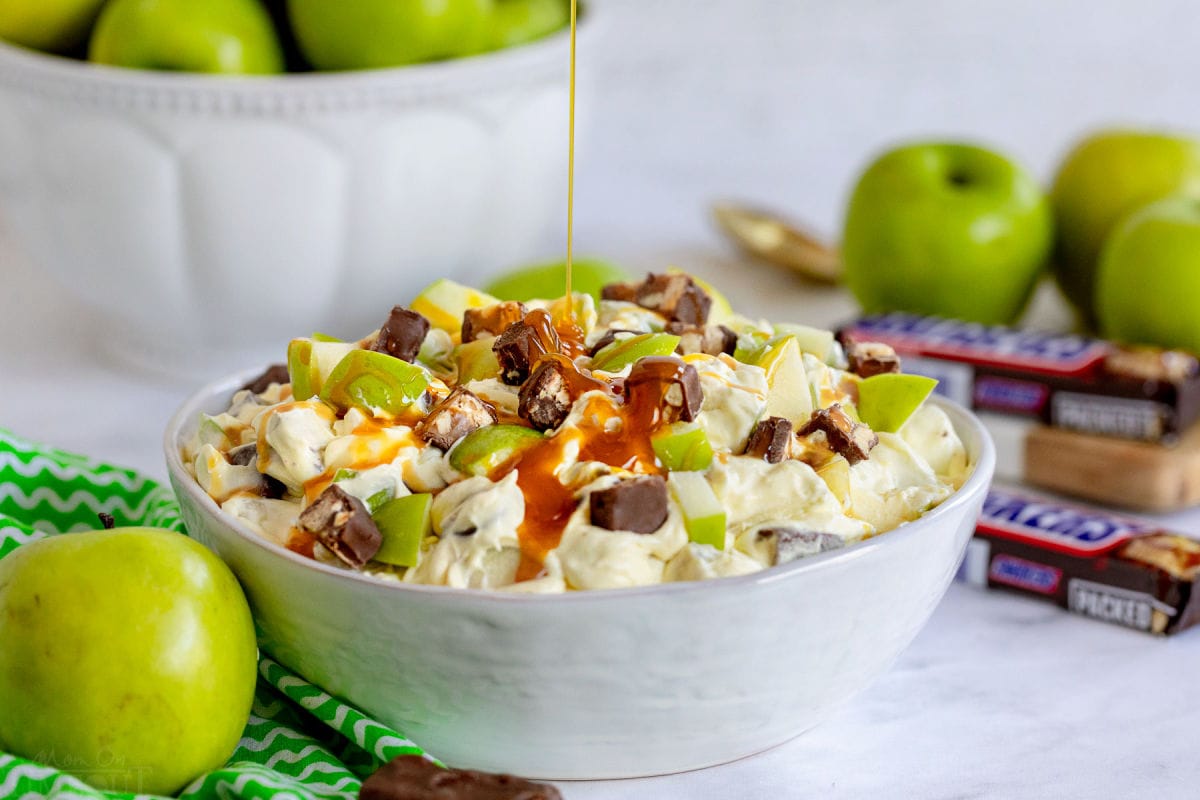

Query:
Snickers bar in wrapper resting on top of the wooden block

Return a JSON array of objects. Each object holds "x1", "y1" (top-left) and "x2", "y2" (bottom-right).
[{"x1": 839, "y1": 313, "x2": 1200, "y2": 443}]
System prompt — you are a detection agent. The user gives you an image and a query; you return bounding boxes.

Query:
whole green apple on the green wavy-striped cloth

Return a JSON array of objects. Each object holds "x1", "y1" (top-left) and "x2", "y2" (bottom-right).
[{"x1": 0, "y1": 528, "x2": 257, "y2": 794}]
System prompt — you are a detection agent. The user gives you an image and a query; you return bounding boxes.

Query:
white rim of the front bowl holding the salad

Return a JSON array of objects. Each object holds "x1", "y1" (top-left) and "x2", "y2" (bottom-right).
[{"x1": 163, "y1": 368, "x2": 996, "y2": 604}]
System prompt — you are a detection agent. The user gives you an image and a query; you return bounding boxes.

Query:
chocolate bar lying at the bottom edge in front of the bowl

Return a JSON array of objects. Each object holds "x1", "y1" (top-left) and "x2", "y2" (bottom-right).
[{"x1": 359, "y1": 756, "x2": 563, "y2": 800}]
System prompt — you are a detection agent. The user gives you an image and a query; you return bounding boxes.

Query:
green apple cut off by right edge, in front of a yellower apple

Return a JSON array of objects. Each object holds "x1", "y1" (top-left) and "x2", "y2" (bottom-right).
[{"x1": 1096, "y1": 197, "x2": 1200, "y2": 354}]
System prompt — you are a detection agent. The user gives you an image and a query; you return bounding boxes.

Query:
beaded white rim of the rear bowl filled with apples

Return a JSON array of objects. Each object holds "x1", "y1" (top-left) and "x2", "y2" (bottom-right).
[{"x1": 0, "y1": 2, "x2": 602, "y2": 115}]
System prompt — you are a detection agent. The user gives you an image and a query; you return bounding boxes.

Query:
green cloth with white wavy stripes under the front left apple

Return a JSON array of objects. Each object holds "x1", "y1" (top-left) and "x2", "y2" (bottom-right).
[{"x1": 0, "y1": 431, "x2": 436, "y2": 800}]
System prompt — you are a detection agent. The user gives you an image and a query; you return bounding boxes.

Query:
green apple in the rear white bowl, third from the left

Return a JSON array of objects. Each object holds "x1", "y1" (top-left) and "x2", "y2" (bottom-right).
[{"x1": 288, "y1": 0, "x2": 494, "y2": 71}]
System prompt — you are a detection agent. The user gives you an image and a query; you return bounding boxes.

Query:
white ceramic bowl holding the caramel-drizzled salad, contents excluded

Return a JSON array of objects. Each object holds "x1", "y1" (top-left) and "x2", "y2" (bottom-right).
[{"x1": 164, "y1": 374, "x2": 996, "y2": 780}]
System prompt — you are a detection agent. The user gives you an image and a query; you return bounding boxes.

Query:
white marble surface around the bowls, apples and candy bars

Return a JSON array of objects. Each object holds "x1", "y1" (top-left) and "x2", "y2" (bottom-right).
[{"x1": 0, "y1": 0, "x2": 1200, "y2": 800}]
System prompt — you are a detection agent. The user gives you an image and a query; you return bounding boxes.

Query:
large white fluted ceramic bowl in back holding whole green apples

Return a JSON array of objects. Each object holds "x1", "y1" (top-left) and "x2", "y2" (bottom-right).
[{"x1": 0, "y1": 25, "x2": 585, "y2": 375}]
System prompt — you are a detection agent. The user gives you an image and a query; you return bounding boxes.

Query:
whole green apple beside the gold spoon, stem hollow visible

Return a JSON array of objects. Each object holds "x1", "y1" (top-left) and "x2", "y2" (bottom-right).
[{"x1": 842, "y1": 143, "x2": 1051, "y2": 323}]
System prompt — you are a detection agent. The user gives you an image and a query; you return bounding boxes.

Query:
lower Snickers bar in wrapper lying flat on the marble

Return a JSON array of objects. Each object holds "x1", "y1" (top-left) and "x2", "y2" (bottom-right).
[{"x1": 958, "y1": 487, "x2": 1200, "y2": 636}]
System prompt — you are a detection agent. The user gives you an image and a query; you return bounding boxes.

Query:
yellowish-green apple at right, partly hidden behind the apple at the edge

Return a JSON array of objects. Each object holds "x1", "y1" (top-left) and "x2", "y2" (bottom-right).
[{"x1": 1050, "y1": 131, "x2": 1200, "y2": 323}]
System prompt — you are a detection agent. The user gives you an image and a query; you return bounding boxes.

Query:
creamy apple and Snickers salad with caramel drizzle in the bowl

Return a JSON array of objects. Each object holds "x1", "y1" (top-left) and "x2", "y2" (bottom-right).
[{"x1": 184, "y1": 272, "x2": 970, "y2": 593}]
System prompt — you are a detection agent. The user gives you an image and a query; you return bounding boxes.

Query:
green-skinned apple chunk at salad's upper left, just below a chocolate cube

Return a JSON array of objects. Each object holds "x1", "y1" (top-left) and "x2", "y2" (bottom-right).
[{"x1": 320, "y1": 350, "x2": 430, "y2": 416}]
